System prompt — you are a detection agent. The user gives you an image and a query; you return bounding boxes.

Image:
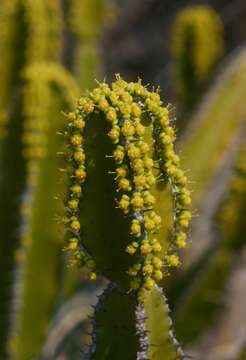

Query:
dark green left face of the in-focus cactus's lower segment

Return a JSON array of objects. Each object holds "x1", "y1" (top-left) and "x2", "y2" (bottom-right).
[{"x1": 87, "y1": 284, "x2": 138, "y2": 360}]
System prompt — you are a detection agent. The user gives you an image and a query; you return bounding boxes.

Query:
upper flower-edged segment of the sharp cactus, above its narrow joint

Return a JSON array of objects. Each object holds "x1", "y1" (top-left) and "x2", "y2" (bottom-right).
[{"x1": 62, "y1": 78, "x2": 190, "y2": 286}]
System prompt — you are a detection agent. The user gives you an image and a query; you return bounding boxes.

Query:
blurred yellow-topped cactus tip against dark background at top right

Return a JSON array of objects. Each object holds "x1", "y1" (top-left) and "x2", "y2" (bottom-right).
[{"x1": 171, "y1": 5, "x2": 224, "y2": 110}]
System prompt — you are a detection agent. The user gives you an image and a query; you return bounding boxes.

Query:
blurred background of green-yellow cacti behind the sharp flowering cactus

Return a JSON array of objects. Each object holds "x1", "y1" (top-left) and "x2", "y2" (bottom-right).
[{"x1": 0, "y1": 0, "x2": 246, "y2": 360}]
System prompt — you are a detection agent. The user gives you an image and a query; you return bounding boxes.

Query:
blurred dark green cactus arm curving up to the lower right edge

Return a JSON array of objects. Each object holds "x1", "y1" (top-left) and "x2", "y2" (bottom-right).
[{"x1": 175, "y1": 141, "x2": 246, "y2": 343}]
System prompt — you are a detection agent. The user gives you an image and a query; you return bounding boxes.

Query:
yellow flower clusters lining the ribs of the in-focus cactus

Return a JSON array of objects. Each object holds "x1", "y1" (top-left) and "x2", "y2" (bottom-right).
[{"x1": 62, "y1": 76, "x2": 191, "y2": 289}]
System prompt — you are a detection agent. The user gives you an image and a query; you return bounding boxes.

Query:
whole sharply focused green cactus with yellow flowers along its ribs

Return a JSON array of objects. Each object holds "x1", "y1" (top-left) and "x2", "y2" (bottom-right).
[{"x1": 60, "y1": 76, "x2": 191, "y2": 359}]
